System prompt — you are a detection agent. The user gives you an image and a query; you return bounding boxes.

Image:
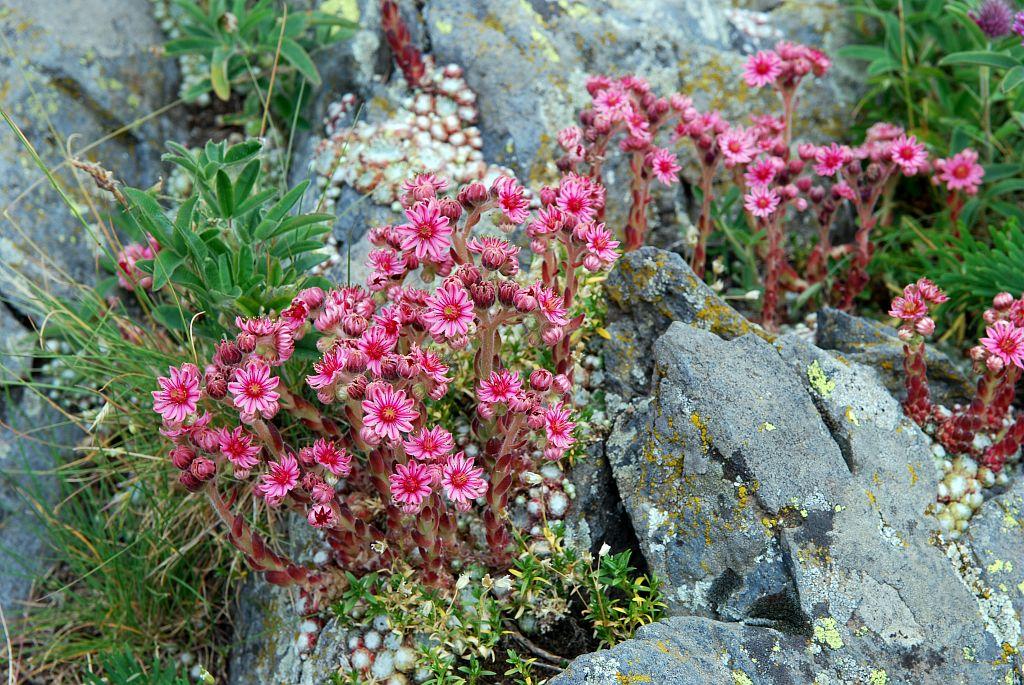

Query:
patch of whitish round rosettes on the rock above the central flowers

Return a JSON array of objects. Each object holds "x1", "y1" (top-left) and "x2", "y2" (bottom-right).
[{"x1": 303, "y1": 57, "x2": 511, "y2": 211}]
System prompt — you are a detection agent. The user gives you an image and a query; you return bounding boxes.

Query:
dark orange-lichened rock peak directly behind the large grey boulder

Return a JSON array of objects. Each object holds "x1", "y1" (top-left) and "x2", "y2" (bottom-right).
[{"x1": 602, "y1": 247, "x2": 767, "y2": 399}]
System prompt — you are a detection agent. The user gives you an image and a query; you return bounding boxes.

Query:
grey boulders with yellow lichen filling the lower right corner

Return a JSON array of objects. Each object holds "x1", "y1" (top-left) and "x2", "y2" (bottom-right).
[{"x1": 553, "y1": 249, "x2": 1024, "y2": 685}]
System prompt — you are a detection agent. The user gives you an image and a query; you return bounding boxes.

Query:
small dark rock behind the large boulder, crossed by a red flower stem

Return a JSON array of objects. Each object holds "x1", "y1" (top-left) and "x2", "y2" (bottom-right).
[{"x1": 814, "y1": 307, "x2": 974, "y2": 406}]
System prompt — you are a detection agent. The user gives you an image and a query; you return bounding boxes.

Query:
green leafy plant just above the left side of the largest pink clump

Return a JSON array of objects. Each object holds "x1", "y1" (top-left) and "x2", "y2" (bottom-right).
[{"x1": 123, "y1": 140, "x2": 334, "y2": 339}]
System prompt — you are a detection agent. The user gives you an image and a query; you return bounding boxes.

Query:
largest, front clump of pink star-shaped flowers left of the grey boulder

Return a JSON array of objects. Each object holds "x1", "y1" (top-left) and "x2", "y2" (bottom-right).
[{"x1": 154, "y1": 174, "x2": 617, "y2": 591}]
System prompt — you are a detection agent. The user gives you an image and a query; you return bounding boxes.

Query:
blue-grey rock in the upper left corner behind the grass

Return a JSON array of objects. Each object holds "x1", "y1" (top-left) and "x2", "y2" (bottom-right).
[{"x1": 0, "y1": 0, "x2": 180, "y2": 298}]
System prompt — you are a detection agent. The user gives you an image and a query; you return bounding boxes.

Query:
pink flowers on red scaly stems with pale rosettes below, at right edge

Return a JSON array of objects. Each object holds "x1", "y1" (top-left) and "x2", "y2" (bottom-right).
[{"x1": 889, "y1": 279, "x2": 1024, "y2": 537}]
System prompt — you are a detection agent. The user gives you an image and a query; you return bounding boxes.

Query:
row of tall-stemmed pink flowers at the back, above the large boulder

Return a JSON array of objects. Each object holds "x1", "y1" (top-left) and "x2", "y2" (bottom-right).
[{"x1": 558, "y1": 42, "x2": 984, "y2": 329}]
